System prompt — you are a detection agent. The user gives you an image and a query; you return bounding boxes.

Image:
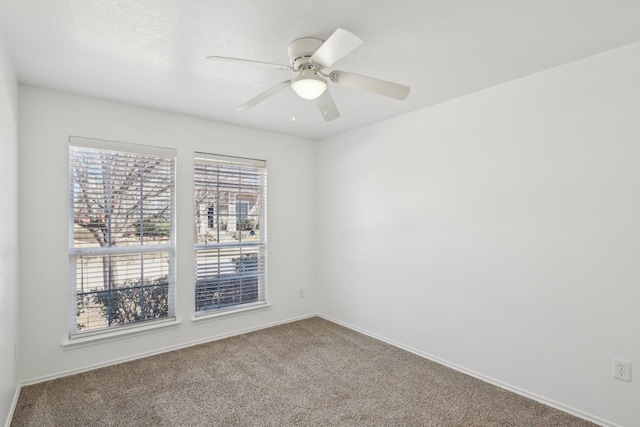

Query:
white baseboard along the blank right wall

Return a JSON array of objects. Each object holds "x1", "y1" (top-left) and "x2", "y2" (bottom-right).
[{"x1": 318, "y1": 314, "x2": 622, "y2": 427}]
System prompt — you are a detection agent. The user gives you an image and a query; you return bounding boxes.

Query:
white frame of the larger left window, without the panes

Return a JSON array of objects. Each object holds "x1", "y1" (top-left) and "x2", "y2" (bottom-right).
[{"x1": 68, "y1": 136, "x2": 179, "y2": 340}]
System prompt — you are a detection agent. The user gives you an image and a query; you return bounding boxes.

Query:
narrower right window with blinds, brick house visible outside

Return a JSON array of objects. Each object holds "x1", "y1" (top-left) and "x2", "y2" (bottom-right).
[{"x1": 194, "y1": 153, "x2": 267, "y2": 315}]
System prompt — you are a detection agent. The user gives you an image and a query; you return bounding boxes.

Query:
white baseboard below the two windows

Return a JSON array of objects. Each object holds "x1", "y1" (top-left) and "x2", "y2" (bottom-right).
[{"x1": 21, "y1": 313, "x2": 317, "y2": 390}]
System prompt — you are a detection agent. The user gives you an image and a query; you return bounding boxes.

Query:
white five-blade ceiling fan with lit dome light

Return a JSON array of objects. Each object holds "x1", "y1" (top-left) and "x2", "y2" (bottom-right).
[{"x1": 207, "y1": 28, "x2": 410, "y2": 121}]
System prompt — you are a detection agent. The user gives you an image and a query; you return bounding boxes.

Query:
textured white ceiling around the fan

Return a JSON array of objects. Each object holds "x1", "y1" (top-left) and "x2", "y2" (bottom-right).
[{"x1": 0, "y1": 0, "x2": 640, "y2": 139}]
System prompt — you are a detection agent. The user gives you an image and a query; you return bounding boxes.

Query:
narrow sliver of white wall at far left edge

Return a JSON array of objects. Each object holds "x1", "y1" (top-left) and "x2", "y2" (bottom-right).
[{"x1": 0, "y1": 29, "x2": 18, "y2": 423}]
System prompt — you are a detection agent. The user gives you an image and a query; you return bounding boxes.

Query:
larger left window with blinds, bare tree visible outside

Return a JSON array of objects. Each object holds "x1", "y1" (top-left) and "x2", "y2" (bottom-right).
[{"x1": 69, "y1": 138, "x2": 175, "y2": 336}]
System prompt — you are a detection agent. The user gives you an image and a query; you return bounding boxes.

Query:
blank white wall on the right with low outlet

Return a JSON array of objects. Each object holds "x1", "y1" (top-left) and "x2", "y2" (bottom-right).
[{"x1": 318, "y1": 43, "x2": 640, "y2": 426}]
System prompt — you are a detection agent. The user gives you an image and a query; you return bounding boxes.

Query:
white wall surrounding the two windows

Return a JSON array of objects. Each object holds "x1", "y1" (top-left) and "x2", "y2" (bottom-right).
[{"x1": 19, "y1": 86, "x2": 316, "y2": 382}]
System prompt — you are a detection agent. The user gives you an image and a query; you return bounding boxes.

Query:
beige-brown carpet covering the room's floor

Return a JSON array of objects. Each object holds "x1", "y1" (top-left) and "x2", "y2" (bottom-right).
[{"x1": 11, "y1": 318, "x2": 593, "y2": 427}]
